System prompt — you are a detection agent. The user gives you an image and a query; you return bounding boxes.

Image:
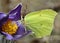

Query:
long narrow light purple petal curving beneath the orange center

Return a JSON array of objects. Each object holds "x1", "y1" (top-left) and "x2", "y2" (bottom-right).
[{"x1": 2, "y1": 30, "x2": 31, "y2": 40}]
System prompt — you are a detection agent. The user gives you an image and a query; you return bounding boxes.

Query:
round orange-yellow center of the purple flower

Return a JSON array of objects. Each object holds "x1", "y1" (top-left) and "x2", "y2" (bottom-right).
[{"x1": 2, "y1": 20, "x2": 18, "y2": 35}]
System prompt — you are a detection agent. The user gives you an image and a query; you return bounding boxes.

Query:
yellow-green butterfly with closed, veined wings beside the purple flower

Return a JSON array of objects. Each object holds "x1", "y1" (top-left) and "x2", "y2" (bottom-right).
[{"x1": 24, "y1": 9, "x2": 57, "y2": 38}]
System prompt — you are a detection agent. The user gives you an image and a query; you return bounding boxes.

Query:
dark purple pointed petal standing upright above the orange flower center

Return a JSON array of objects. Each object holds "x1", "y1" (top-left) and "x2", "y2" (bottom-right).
[{"x1": 9, "y1": 4, "x2": 22, "y2": 21}]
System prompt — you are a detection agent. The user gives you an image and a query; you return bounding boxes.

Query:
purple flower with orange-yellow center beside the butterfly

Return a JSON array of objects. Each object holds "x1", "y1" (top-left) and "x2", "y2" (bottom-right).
[{"x1": 0, "y1": 4, "x2": 31, "y2": 40}]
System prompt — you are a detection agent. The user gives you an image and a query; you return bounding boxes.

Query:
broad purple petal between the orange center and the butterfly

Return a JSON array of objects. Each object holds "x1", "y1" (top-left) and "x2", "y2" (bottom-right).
[{"x1": 13, "y1": 21, "x2": 32, "y2": 40}]
